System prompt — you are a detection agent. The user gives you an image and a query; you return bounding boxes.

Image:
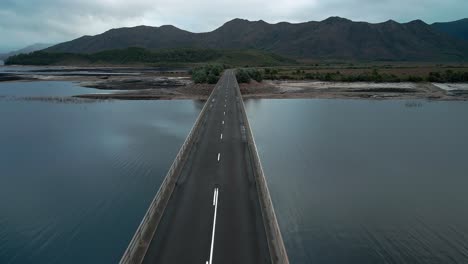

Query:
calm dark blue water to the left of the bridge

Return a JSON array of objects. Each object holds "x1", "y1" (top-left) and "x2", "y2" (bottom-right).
[{"x1": 0, "y1": 82, "x2": 202, "y2": 264}]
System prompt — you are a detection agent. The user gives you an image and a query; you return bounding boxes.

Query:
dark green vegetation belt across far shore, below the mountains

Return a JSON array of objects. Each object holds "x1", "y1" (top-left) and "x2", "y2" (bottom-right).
[{"x1": 5, "y1": 48, "x2": 468, "y2": 83}]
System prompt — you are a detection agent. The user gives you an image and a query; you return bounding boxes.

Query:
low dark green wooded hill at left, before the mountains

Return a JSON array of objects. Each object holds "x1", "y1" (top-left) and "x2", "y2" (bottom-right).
[{"x1": 5, "y1": 48, "x2": 295, "y2": 66}]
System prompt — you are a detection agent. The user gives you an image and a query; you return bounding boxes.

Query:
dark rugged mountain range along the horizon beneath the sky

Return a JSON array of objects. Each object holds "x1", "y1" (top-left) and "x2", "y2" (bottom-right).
[{"x1": 46, "y1": 17, "x2": 468, "y2": 61}]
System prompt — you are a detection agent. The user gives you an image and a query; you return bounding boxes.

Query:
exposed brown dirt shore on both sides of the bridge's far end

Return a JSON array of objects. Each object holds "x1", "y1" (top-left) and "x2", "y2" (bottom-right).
[{"x1": 0, "y1": 68, "x2": 468, "y2": 100}]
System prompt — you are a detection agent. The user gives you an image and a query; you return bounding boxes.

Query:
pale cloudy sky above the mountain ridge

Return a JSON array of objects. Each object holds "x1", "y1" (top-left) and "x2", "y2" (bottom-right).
[{"x1": 0, "y1": 0, "x2": 468, "y2": 52}]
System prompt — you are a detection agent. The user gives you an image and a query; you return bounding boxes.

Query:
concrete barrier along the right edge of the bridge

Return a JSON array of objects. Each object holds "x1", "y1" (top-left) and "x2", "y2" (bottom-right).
[{"x1": 236, "y1": 74, "x2": 289, "y2": 264}]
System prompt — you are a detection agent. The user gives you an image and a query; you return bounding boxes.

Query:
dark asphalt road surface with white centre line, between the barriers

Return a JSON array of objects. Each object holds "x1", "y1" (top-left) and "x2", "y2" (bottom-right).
[{"x1": 143, "y1": 70, "x2": 270, "y2": 264}]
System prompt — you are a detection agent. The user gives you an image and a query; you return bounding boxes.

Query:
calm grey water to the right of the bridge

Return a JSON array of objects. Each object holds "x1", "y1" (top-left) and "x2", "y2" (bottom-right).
[{"x1": 246, "y1": 100, "x2": 468, "y2": 264}]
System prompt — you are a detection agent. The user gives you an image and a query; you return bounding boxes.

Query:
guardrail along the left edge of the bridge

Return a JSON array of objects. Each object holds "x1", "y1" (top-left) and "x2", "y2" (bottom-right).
[{"x1": 120, "y1": 77, "x2": 219, "y2": 264}]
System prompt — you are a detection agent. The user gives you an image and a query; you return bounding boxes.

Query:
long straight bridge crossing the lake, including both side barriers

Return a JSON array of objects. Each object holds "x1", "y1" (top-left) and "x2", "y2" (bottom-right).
[{"x1": 120, "y1": 70, "x2": 289, "y2": 264}]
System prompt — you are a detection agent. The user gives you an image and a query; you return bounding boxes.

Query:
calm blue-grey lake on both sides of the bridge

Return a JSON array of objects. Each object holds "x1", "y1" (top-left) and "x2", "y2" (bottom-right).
[{"x1": 0, "y1": 81, "x2": 468, "y2": 264}]
